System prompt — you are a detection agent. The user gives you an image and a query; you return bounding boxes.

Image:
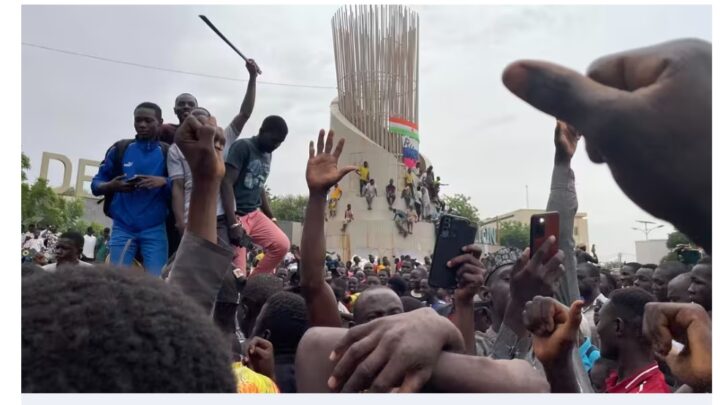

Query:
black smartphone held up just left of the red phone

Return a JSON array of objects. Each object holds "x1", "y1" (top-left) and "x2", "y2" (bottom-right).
[{"x1": 428, "y1": 214, "x2": 477, "y2": 289}]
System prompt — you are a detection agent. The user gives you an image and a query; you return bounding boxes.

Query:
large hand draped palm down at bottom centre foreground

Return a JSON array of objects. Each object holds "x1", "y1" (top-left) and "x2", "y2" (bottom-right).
[{"x1": 328, "y1": 308, "x2": 464, "y2": 392}]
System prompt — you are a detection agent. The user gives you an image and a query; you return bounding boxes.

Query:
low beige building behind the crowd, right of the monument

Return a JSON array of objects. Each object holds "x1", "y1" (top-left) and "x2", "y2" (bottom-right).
[{"x1": 477, "y1": 209, "x2": 591, "y2": 252}]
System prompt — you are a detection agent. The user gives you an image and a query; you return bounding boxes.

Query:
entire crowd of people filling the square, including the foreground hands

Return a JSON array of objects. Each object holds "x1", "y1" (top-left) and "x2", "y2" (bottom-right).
[{"x1": 22, "y1": 40, "x2": 712, "y2": 393}]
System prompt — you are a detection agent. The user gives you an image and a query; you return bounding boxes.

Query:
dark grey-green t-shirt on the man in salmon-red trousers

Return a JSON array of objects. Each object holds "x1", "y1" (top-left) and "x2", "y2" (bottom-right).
[{"x1": 225, "y1": 136, "x2": 272, "y2": 215}]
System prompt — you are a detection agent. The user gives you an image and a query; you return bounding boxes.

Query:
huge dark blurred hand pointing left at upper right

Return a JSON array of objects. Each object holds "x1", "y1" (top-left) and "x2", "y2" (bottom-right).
[{"x1": 503, "y1": 39, "x2": 712, "y2": 250}]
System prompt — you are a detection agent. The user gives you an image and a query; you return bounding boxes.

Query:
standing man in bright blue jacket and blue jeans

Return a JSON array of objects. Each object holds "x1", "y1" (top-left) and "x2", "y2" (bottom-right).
[{"x1": 91, "y1": 102, "x2": 171, "y2": 276}]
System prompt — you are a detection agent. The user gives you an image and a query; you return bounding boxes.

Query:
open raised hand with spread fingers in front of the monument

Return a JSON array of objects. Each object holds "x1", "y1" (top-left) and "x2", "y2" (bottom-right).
[{"x1": 305, "y1": 129, "x2": 357, "y2": 195}]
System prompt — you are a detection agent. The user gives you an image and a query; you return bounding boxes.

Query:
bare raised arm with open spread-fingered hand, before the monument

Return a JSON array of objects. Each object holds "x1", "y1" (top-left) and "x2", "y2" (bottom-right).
[{"x1": 299, "y1": 130, "x2": 355, "y2": 326}]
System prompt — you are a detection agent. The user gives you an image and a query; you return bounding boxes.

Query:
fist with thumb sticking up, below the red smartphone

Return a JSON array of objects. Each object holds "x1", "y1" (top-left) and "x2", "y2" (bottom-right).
[{"x1": 523, "y1": 296, "x2": 583, "y2": 367}]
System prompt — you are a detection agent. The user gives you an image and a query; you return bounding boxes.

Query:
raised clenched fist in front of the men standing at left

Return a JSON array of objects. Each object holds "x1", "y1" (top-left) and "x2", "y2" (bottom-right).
[{"x1": 175, "y1": 111, "x2": 225, "y2": 180}]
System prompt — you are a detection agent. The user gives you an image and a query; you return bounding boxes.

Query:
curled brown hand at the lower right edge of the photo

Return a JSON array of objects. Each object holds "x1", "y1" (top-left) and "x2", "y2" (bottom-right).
[{"x1": 643, "y1": 302, "x2": 712, "y2": 392}]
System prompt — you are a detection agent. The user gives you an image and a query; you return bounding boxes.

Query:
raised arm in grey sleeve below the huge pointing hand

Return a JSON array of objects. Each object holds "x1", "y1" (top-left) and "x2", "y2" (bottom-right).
[{"x1": 547, "y1": 121, "x2": 580, "y2": 305}]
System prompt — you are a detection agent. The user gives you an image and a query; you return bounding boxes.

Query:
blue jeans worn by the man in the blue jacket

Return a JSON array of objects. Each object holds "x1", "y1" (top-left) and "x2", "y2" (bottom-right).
[{"x1": 109, "y1": 222, "x2": 168, "y2": 277}]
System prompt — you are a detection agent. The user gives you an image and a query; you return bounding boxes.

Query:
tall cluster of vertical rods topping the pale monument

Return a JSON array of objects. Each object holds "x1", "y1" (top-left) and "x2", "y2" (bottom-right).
[{"x1": 332, "y1": 5, "x2": 419, "y2": 158}]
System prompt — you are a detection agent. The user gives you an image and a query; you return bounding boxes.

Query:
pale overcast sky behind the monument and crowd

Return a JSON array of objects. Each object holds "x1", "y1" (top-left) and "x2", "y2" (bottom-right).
[{"x1": 22, "y1": 6, "x2": 711, "y2": 260}]
